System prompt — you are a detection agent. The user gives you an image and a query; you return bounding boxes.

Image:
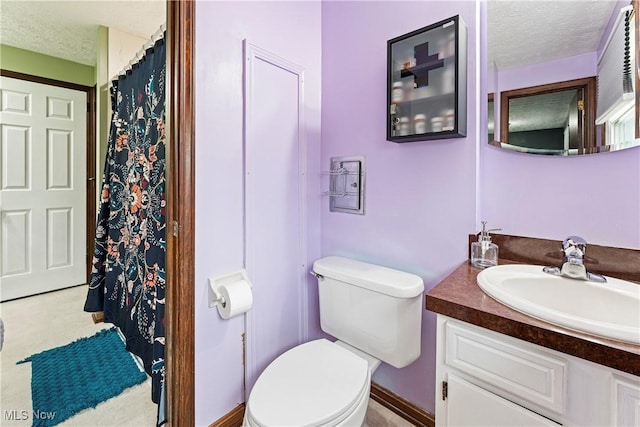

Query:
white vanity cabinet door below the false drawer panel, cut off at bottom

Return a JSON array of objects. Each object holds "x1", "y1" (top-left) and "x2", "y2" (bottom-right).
[{"x1": 447, "y1": 374, "x2": 560, "y2": 427}]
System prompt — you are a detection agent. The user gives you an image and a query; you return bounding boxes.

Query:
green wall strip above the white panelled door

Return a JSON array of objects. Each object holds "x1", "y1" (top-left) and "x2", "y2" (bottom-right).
[{"x1": 0, "y1": 45, "x2": 96, "y2": 86}]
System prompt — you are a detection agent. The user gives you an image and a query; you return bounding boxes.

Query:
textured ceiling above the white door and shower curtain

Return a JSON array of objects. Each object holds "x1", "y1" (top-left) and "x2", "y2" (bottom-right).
[{"x1": 0, "y1": 0, "x2": 166, "y2": 65}]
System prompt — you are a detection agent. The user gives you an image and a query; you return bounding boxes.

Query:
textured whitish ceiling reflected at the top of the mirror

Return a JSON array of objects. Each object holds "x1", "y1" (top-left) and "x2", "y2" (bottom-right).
[{"x1": 487, "y1": 0, "x2": 617, "y2": 71}]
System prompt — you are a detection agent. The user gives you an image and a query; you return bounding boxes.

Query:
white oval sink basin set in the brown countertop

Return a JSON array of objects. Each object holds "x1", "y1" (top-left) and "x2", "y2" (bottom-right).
[{"x1": 478, "y1": 264, "x2": 640, "y2": 344}]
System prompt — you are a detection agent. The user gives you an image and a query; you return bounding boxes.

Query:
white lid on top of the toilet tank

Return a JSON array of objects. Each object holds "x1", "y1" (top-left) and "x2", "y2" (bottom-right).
[{"x1": 313, "y1": 256, "x2": 424, "y2": 298}]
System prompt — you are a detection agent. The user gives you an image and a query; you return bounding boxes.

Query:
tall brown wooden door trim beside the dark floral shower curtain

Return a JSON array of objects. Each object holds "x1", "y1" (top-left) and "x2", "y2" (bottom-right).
[{"x1": 165, "y1": 0, "x2": 195, "y2": 426}]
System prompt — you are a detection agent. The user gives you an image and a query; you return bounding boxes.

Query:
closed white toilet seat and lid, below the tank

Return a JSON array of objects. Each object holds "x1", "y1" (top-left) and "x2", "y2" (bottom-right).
[{"x1": 246, "y1": 339, "x2": 371, "y2": 426}]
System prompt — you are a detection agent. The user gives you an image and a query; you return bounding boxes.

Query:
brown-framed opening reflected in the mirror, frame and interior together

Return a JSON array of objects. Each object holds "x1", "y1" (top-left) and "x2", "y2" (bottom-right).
[{"x1": 500, "y1": 77, "x2": 596, "y2": 156}]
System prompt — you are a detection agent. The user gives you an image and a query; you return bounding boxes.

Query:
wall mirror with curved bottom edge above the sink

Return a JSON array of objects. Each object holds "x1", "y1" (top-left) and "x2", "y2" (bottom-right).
[{"x1": 486, "y1": 0, "x2": 640, "y2": 155}]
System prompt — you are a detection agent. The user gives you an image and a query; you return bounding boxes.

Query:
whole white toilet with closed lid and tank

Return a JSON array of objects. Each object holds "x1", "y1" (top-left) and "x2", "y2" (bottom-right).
[{"x1": 243, "y1": 256, "x2": 424, "y2": 427}]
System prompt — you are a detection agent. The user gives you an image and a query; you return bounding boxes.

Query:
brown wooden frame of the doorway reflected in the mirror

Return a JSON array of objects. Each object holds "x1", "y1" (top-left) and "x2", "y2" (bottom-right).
[{"x1": 494, "y1": 76, "x2": 597, "y2": 154}]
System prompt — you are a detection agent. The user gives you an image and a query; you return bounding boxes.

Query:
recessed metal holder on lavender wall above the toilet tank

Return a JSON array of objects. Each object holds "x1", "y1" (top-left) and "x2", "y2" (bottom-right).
[{"x1": 323, "y1": 156, "x2": 365, "y2": 215}]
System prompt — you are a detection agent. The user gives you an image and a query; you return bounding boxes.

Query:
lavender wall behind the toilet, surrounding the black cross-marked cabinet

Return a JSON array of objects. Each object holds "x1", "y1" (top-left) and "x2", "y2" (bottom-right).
[{"x1": 322, "y1": 1, "x2": 478, "y2": 413}]
